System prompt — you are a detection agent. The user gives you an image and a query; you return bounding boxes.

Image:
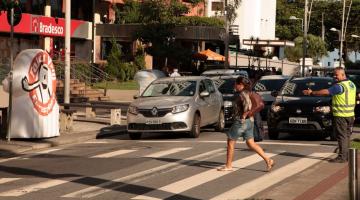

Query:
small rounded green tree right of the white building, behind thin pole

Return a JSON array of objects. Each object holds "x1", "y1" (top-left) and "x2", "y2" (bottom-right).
[{"x1": 285, "y1": 34, "x2": 327, "y2": 62}]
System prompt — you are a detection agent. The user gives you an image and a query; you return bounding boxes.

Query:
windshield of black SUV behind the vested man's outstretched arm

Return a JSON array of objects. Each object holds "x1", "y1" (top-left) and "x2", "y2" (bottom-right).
[{"x1": 280, "y1": 79, "x2": 333, "y2": 97}]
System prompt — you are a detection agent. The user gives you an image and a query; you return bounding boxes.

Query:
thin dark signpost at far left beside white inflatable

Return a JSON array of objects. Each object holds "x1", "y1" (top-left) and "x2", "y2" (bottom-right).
[{"x1": 6, "y1": 7, "x2": 14, "y2": 142}]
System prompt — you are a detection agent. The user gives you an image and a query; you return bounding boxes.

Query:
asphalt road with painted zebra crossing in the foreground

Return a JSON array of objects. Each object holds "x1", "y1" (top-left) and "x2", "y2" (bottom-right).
[{"x1": 0, "y1": 130, "x2": 341, "y2": 200}]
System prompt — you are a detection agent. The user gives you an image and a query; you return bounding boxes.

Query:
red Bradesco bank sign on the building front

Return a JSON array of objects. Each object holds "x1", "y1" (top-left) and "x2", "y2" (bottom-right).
[{"x1": 0, "y1": 12, "x2": 91, "y2": 39}]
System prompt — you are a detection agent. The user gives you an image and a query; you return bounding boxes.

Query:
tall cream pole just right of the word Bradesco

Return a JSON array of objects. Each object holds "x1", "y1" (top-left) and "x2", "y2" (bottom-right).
[{"x1": 64, "y1": 0, "x2": 71, "y2": 103}]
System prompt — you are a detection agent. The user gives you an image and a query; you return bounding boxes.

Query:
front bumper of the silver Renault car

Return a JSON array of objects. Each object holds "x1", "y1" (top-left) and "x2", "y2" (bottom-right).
[{"x1": 127, "y1": 110, "x2": 194, "y2": 132}]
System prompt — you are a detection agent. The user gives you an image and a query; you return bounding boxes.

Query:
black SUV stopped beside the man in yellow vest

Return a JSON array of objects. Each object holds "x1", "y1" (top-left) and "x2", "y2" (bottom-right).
[{"x1": 267, "y1": 77, "x2": 335, "y2": 140}]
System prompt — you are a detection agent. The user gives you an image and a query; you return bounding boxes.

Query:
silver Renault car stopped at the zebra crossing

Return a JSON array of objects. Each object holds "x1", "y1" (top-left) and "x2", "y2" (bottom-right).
[{"x1": 127, "y1": 76, "x2": 225, "y2": 139}]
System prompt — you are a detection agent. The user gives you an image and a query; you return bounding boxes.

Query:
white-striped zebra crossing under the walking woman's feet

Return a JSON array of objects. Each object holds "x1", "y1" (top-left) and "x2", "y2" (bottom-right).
[{"x1": 0, "y1": 143, "x2": 334, "y2": 200}]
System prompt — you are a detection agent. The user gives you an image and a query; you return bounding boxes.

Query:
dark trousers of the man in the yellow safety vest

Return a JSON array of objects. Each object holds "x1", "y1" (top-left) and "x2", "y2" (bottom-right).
[{"x1": 334, "y1": 117, "x2": 354, "y2": 160}]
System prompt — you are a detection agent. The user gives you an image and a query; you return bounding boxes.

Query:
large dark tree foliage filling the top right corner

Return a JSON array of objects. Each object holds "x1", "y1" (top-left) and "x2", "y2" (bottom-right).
[{"x1": 276, "y1": 0, "x2": 360, "y2": 53}]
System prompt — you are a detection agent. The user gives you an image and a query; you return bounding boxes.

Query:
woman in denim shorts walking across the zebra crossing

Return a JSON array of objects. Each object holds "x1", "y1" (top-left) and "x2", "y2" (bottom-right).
[{"x1": 218, "y1": 77, "x2": 274, "y2": 171}]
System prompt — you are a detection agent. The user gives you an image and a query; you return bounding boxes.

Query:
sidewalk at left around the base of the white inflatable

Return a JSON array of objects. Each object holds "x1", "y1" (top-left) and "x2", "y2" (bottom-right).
[{"x1": 0, "y1": 121, "x2": 126, "y2": 158}]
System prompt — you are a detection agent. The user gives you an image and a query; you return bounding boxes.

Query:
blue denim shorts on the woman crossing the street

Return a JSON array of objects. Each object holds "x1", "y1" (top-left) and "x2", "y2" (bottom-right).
[{"x1": 227, "y1": 119, "x2": 254, "y2": 141}]
